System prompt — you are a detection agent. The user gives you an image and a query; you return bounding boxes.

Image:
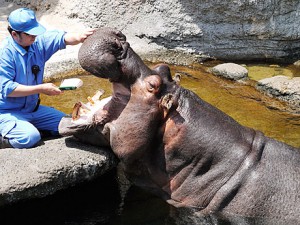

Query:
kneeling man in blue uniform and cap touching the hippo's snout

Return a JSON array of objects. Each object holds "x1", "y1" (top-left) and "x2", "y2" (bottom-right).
[{"x1": 0, "y1": 8, "x2": 93, "y2": 148}]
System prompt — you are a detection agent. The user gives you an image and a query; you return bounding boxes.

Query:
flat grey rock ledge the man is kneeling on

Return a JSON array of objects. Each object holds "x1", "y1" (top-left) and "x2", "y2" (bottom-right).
[{"x1": 0, "y1": 137, "x2": 117, "y2": 206}]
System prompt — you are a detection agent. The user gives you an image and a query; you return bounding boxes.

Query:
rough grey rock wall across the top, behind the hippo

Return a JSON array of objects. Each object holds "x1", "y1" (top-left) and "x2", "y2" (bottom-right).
[{"x1": 9, "y1": 0, "x2": 300, "y2": 62}]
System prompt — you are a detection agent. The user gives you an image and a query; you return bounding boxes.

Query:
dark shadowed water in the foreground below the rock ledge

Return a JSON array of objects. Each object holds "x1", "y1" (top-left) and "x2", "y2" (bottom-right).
[{"x1": 0, "y1": 170, "x2": 299, "y2": 225}]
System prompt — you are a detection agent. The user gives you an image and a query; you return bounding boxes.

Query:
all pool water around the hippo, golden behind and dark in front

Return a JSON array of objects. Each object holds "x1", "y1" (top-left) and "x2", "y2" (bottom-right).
[{"x1": 0, "y1": 64, "x2": 300, "y2": 225}]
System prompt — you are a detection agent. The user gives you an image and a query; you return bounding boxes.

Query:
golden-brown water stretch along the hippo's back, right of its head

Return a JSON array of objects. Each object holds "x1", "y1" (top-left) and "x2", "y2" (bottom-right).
[{"x1": 172, "y1": 63, "x2": 300, "y2": 147}]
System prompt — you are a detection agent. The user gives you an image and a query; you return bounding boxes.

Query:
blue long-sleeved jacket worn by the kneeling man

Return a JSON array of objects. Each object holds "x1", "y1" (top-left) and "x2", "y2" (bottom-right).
[{"x1": 0, "y1": 30, "x2": 66, "y2": 113}]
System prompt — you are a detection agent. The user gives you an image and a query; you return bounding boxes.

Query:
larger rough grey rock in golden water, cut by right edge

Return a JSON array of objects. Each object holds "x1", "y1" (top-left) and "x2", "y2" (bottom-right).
[{"x1": 256, "y1": 75, "x2": 300, "y2": 108}]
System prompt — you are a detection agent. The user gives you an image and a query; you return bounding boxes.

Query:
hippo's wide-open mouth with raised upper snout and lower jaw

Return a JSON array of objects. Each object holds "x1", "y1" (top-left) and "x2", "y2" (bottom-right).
[{"x1": 59, "y1": 28, "x2": 176, "y2": 146}]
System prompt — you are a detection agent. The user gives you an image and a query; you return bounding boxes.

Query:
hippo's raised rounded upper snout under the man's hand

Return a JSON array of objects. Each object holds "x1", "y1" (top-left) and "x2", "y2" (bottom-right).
[{"x1": 78, "y1": 28, "x2": 151, "y2": 85}]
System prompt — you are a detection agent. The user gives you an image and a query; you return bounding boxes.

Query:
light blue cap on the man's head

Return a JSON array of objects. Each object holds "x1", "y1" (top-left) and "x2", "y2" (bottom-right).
[{"x1": 7, "y1": 8, "x2": 46, "y2": 35}]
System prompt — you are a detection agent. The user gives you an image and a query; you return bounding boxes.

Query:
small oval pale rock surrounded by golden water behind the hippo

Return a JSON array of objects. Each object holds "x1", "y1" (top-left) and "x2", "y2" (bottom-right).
[{"x1": 210, "y1": 63, "x2": 248, "y2": 80}]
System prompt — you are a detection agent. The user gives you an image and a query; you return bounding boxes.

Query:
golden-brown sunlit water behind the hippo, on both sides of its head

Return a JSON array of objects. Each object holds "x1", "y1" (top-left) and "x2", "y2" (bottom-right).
[{"x1": 42, "y1": 64, "x2": 300, "y2": 147}]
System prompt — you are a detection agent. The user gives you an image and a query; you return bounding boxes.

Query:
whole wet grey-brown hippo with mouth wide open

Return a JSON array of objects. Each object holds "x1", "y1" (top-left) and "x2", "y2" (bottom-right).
[{"x1": 60, "y1": 28, "x2": 300, "y2": 221}]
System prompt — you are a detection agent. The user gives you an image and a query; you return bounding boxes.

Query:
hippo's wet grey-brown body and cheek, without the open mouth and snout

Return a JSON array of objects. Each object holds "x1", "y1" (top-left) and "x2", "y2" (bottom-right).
[{"x1": 106, "y1": 73, "x2": 300, "y2": 221}]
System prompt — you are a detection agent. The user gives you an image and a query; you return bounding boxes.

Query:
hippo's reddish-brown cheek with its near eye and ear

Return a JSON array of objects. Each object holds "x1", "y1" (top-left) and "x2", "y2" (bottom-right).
[{"x1": 103, "y1": 75, "x2": 175, "y2": 164}]
